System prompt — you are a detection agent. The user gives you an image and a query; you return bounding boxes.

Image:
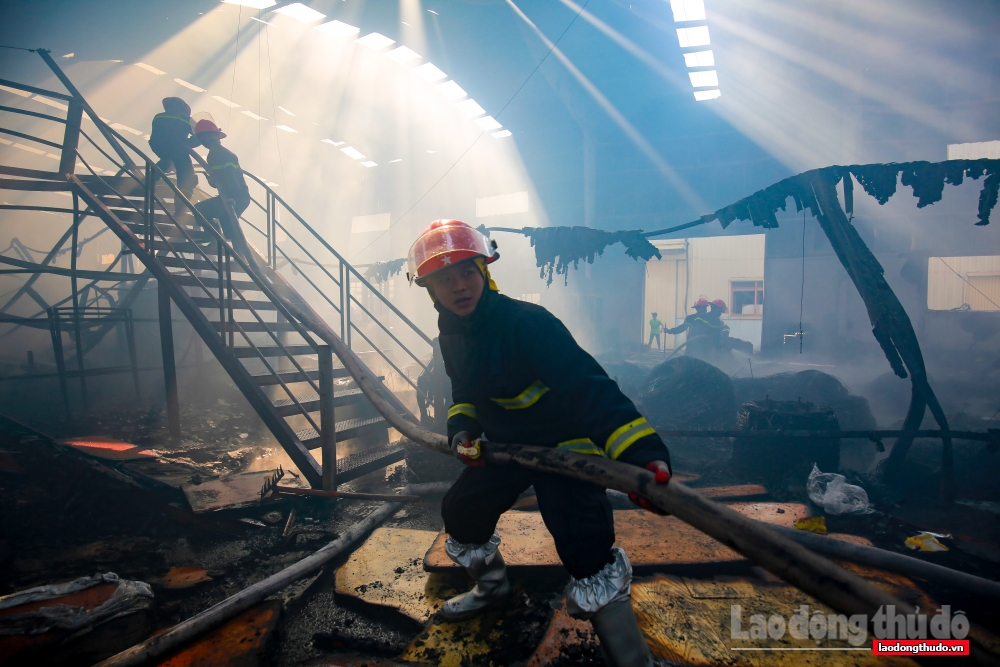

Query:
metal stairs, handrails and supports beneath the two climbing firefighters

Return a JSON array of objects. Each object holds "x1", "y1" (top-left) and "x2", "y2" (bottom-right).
[{"x1": 0, "y1": 50, "x2": 431, "y2": 489}]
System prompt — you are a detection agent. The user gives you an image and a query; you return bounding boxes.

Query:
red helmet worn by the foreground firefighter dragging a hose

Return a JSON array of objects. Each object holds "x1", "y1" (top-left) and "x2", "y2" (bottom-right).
[{"x1": 406, "y1": 220, "x2": 500, "y2": 286}]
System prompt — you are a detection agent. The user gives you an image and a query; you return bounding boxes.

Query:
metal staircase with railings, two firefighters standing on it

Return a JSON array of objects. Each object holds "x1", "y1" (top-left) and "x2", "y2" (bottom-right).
[{"x1": 0, "y1": 51, "x2": 431, "y2": 489}]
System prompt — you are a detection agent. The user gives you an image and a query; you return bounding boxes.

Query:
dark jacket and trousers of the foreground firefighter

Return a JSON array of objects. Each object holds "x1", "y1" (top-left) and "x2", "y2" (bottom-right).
[{"x1": 437, "y1": 288, "x2": 669, "y2": 579}]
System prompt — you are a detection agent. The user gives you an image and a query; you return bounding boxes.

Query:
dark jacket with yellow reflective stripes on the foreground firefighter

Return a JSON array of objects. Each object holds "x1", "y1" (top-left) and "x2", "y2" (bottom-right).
[{"x1": 437, "y1": 290, "x2": 669, "y2": 465}]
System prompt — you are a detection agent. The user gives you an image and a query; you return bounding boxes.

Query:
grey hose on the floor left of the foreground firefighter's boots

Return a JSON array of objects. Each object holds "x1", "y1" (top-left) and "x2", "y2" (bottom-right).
[{"x1": 94, "y1": 483, "x2": 450, "y2": 667}]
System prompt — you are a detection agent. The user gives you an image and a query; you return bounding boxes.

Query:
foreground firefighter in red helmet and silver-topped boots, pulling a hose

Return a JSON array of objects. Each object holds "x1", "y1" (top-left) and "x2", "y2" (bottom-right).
[{"x1": 408, "y1": 220, "x2": 670, "y2": 667}]
